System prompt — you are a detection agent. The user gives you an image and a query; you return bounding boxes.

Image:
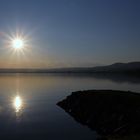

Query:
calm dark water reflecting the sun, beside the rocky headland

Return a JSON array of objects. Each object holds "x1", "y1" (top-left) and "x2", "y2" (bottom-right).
[{"x1": 0, "y1": 74, "x2": 140, "y2": 140}]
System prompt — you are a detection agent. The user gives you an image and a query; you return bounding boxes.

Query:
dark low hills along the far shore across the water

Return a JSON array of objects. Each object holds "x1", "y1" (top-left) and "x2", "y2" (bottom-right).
[{"x1": 0, "y1": 62, "x2": 140, "y2": 74}]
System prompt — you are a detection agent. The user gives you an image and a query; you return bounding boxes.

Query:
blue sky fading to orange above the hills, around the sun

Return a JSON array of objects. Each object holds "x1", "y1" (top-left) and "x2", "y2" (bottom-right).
[{"x1": 0, "y1": 0, "x2": 140, "y2": 68}]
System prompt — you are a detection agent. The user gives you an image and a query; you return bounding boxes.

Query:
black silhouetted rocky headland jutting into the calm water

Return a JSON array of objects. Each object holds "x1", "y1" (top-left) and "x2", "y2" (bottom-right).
[{"x1": 57, "y1": 90, "x2": 140, "y2": 140}]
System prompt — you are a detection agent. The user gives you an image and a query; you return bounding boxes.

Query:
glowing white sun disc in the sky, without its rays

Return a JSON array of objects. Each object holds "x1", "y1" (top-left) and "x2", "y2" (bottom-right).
[{"x1": 12, "y1": 38, "x2": 24, "y2": 49}]
